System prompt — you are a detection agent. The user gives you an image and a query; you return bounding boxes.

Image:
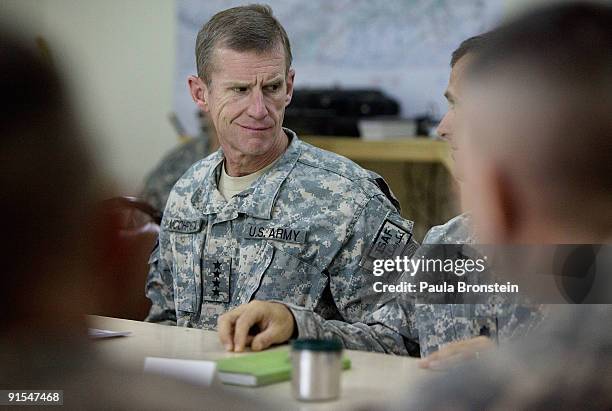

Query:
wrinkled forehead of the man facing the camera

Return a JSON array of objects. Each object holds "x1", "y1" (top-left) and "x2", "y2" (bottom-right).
[{"x1": 211, "y1": 45, "x2": 286, "y2": 82}]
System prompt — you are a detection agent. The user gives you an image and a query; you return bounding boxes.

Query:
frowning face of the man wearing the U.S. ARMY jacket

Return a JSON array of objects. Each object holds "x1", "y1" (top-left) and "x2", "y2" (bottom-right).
[{"x1": 196, "y1": 46, "x2": 294, "y2": 156}]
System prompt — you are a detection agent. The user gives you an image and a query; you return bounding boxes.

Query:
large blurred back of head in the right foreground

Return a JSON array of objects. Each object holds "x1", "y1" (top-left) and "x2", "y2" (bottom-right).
[{"x1": 466, "y1": 3, "x2": 612, "y2": 240}]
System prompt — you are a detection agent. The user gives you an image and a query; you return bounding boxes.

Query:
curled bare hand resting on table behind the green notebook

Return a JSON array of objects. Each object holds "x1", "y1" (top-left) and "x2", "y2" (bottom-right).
[{"x1": 217, "y1": 301, "x2": 295, "y2": 352}]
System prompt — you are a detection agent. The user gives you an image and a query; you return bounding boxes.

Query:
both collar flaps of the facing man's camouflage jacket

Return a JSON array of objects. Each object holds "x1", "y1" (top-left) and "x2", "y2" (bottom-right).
[{"x1": 191, "y1": 127, "x2": 302, "y2": 220}]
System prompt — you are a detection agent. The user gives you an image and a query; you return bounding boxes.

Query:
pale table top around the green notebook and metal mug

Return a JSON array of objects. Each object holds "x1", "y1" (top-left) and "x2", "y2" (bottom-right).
[{"x1": 89, "y1": 316, "x2": 436, "y2": 411}]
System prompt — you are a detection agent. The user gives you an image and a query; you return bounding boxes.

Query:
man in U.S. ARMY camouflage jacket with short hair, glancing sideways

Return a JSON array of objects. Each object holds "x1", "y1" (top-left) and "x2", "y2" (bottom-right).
[{"x1": 146, "y1": 5, "x2": 416, "y2": 334}]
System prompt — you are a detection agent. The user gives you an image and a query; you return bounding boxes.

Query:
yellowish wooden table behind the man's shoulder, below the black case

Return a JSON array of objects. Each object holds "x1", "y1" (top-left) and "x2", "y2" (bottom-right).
[{"x1": 303, "y1": 136, "x2": 459, "y2": 241}]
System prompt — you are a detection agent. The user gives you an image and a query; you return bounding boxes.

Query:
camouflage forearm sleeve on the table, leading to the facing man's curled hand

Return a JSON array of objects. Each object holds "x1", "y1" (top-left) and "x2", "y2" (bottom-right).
[{"x1": 286, "y1": 292, "x2": 419, "y2": 356}]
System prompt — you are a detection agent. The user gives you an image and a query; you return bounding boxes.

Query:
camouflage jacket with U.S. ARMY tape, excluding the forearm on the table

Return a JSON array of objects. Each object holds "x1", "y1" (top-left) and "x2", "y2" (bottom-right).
[{"x1": 147, "y1": 130, "x2": 417, "y2": 329}]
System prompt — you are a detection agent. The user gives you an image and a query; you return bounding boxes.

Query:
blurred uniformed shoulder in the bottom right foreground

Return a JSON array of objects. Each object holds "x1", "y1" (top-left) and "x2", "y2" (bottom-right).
[{"x1": 404, "y1": 304, "x2": 612, "y2": 410}]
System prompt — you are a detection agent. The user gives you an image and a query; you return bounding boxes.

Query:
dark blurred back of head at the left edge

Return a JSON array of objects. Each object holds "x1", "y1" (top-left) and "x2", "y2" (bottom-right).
[{"x1": 0, "y1": 34, "x2": 91, "y2": 326}]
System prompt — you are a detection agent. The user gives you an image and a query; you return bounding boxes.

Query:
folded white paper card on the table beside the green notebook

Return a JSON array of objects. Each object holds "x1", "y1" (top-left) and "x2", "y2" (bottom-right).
[{"x1": 144, "y1": 357, "x2": 220, "y2": 387}]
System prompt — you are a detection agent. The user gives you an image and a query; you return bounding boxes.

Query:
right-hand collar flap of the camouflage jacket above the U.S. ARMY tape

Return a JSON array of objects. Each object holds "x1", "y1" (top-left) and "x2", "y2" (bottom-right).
[{"x1": 238, "y1": 127, "x2": 302, "y2": 220}]
